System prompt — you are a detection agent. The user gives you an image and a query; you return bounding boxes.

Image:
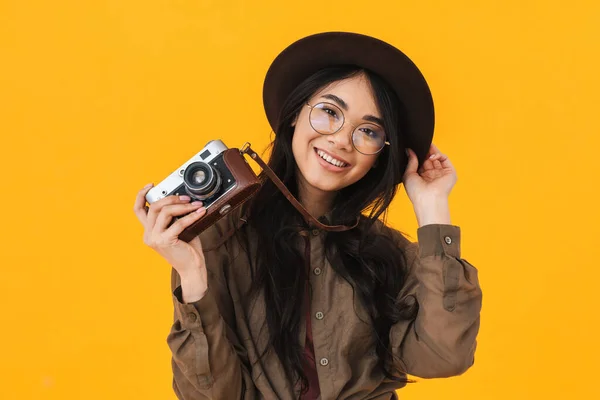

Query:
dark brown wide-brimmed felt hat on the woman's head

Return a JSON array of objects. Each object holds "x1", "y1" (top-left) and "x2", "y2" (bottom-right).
[{"x1": 263, "y1": 32, "x2": 434, "y2": 183}]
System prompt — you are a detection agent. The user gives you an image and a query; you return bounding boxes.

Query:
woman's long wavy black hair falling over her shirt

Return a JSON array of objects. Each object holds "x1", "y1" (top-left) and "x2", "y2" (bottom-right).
[{"x1": 241, "y1": 66, "x2": 416, "y2": 390}]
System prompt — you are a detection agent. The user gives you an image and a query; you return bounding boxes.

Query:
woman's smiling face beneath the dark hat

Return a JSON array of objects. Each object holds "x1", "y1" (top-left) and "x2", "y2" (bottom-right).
[{"x1": 292, "y1": 74, "x2": 382, "y2": 192}]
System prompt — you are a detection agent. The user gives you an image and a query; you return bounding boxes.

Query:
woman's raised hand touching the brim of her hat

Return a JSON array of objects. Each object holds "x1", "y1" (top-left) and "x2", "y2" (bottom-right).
[{"x1": 403, "y1": 143, "x2": 457, "y2": 223}]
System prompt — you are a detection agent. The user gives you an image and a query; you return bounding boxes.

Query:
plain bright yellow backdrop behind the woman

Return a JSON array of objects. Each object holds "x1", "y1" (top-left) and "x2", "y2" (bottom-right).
[{"x1": 0, "y1": 0, "x2": 600, "y2": 400}]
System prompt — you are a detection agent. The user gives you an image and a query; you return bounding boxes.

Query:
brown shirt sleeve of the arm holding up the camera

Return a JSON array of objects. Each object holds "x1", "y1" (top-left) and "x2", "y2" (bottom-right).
[{"x1": 167, "y1": 219, "x2": 254, "y2": 400}]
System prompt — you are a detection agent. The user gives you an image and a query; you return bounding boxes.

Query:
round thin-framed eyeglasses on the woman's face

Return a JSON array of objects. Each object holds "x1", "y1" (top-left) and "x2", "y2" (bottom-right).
[{"x1": 306, "y1": 102, "x2": 390, "y2": 155}]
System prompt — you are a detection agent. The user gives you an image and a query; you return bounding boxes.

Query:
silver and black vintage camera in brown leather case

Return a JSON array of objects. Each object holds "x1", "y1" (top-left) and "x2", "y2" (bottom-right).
[{"x1": 146, "y1": 140, "x2": 260, "y2": 242}]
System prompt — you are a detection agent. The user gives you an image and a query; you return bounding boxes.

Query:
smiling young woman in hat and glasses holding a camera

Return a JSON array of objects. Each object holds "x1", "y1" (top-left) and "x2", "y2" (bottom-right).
[{"x1": 135, "y1": 32, "x2": 482, "y2": 400}]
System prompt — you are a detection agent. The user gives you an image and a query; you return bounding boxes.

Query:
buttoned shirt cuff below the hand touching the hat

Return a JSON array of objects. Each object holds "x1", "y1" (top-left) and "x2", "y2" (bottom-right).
[{"x1": 417, "y1": 224, "x2": 460, "y2": 258}]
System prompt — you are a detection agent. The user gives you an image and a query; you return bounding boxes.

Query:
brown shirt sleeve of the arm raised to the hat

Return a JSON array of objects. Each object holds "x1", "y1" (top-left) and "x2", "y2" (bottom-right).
[{"x1": 390, "y1": 224, "x2": 482, "y2": 378}]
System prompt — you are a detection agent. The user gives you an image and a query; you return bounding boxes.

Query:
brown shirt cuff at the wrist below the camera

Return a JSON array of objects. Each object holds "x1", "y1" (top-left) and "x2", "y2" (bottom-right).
[{"x1": 173, "y1": 286, "x2": 221, "y2": 329}]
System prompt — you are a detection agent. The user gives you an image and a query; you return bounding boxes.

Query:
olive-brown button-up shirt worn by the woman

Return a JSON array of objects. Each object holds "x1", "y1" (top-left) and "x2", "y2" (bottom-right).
[{"x1": 167, "y1": 211, "x2": 482, "y2": 400}]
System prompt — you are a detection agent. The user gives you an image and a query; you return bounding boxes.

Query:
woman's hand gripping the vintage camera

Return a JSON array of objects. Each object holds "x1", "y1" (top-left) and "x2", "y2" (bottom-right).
[{"x1": 133, "y1": 184, "x2": 207, "y2": 288}]
